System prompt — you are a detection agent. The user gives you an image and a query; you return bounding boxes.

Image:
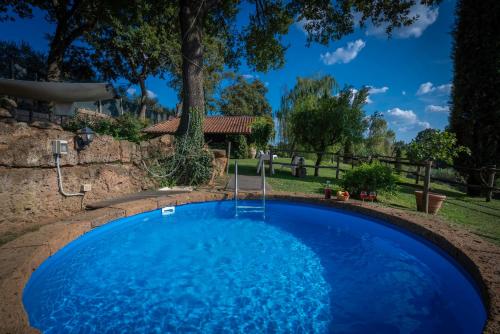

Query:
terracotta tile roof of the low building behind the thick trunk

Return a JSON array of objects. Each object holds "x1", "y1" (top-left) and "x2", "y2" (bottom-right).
[{"x1": 144, "y1": 116, "x2": 255, "y2": 135}]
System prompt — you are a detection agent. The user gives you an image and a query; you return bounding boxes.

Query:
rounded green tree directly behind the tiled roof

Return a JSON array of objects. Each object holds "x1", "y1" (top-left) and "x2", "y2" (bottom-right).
[{"x1": 219, "y1": 76, "x2": 271, "y2": 116}]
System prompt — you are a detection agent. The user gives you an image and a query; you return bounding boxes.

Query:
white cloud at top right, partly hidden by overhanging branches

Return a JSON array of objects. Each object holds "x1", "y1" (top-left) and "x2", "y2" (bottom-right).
[{"x1": 366, "y1": 3, "x2": 439, "y2": 38}]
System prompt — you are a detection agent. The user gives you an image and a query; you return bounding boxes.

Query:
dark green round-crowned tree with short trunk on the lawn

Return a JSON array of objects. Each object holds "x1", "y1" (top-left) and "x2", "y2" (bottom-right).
[{"x1": 290, "y1": 78, "x2": 368, "y2": 176}]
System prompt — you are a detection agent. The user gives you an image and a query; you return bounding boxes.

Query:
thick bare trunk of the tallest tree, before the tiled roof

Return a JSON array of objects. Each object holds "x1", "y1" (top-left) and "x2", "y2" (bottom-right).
[{"x1": 177, "y1": 0, "x2": 205, "y2": 138}]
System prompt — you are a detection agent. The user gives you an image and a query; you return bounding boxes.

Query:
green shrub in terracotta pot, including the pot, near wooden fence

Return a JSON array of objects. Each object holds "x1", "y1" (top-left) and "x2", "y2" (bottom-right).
[{"x1": 408, "y1": 129, "x2": 469, "y2": 214}]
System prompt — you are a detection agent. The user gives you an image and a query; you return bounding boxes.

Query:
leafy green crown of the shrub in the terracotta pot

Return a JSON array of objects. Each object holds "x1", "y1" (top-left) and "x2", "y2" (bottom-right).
[{"x1": 408, "y1": 129, "x2": 470, "y2": 164}]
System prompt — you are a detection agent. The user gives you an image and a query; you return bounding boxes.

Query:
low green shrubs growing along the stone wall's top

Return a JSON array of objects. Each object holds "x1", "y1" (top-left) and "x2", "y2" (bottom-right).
[{"x1": 64, "y1": 113, "x2": 148, "y2": 143}]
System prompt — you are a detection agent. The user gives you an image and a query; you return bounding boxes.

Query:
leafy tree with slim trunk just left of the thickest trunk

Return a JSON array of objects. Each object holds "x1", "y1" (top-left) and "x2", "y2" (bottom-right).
[{"x1": 86, "y1": 1, "x2": 178, "y2": 119}]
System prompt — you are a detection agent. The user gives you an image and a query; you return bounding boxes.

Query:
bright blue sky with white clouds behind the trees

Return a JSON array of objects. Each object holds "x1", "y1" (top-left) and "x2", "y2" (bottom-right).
[{"x1": 0, "y1": 0, "x2": 455, "y2": 141}]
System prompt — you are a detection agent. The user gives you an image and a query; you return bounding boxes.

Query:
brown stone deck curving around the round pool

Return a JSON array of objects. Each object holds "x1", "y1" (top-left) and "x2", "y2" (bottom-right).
[{"x1": 0, "y1": 190, "x2": 500, "y2": 334}]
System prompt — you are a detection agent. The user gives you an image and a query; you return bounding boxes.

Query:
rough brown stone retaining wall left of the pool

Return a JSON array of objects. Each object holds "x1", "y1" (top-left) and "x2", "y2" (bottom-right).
[{"x1": 0, "y1": 122, "x2": 173, "y2": 228}]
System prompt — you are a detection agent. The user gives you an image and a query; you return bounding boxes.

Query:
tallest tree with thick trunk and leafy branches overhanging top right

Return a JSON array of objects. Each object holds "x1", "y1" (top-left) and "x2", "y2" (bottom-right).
[{"x1": 178, "y1": 0, "x2": 439, "y2": 145}]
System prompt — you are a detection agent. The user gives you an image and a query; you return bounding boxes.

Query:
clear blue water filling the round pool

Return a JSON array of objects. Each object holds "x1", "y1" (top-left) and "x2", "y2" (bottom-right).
[{"x1": 23, "y1": 201, "x2": 486, "y2": 334}]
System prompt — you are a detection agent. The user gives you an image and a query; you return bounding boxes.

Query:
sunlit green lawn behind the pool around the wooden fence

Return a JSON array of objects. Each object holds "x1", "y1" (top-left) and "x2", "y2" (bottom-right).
[{"x1": 230, "y1": 158, "x2": 500, "y2": 244}]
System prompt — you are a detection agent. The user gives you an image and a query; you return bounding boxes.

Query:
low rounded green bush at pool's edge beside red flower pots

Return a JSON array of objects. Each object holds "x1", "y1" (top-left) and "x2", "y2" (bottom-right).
[{"x1": 342, "y1": 163, "x2": 397, "y2": 194}]
